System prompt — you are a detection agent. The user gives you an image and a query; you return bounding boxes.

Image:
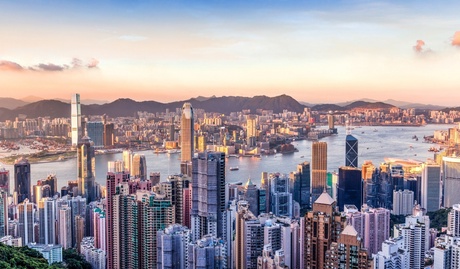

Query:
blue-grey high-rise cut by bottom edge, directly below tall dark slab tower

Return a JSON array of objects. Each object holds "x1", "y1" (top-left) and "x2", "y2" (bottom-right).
[{"x1": 188, "y1": 235, "x2": 227, "y2": 269}]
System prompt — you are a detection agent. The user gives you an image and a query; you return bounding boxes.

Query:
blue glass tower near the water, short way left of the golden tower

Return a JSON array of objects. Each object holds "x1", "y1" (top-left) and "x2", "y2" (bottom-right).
[{"x1": 268, "y1": 173, "x2": 293, "y2": 217}]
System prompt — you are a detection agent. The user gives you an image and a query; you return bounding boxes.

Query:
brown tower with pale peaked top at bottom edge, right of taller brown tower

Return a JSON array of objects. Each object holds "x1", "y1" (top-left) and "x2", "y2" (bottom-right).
[{"x1": 325, "y1": 225, "x2": 372, "y2": 269}]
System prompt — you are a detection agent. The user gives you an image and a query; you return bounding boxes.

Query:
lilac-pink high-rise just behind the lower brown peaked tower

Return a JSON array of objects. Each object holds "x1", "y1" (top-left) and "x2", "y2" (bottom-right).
[{"x1": 344, "y1": 205, "x2": 390, "y2": 255}]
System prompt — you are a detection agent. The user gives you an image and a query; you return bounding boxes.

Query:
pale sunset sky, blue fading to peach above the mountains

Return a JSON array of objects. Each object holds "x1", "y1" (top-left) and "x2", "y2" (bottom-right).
[{"x1": 0, "y1": 0, "x2": 460, "y2": 106}]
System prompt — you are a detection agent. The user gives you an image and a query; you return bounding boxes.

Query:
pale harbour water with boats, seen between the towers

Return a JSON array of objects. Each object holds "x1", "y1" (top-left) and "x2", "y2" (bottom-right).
[{"x1": 2, "y1": 125, "x2": 452, "y2": 189}]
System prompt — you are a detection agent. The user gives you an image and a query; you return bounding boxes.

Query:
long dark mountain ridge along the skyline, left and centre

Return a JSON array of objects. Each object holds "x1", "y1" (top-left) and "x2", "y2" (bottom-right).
[{"x1": 0, "y1": 95, "x2": 305, "y2": 121}]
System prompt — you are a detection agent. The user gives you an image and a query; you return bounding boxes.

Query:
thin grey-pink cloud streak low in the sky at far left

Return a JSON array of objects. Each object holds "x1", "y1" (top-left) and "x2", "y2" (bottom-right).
[{"x1": 0, "y1": 58, "x2": 99, "y2": 72}]
